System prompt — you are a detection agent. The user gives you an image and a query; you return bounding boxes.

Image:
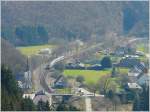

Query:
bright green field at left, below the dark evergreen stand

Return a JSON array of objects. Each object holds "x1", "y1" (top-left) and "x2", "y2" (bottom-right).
[{"x1": 17, "y1": 44, "x2": 54, "y2": 56}]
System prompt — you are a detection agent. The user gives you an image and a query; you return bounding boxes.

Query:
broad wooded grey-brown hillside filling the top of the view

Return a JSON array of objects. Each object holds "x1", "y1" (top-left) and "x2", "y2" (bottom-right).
[{"x1": 2, "y1": 1, "x2": 148, "y2": 45}]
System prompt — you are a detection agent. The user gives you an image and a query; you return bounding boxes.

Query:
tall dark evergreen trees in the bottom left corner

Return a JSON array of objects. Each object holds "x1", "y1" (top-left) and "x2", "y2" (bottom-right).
[{"x1": 1, "y1": 65, "x2": 22, "y2": 111}]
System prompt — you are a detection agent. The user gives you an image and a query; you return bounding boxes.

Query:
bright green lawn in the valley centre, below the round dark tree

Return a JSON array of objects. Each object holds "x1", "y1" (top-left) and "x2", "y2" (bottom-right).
[{"x1": 64, "y1": 69, "x2": 111, "y2": 84}]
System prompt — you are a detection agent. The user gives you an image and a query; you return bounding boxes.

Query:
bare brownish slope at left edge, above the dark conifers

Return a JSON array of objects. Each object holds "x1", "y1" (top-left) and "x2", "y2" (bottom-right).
[{"x1": 1, "y1": 39, "x2": 26, "y2": 74}]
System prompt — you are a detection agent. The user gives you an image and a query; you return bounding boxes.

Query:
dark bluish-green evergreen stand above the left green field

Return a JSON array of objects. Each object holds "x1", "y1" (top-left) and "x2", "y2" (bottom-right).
[{"x1": 2, "y1": 25, "x2": 48, "y2": 46}]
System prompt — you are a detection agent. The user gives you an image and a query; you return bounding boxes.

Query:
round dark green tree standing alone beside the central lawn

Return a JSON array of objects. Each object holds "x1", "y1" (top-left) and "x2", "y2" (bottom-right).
[{"x1": 101, "y1": 56, "x2": 112, "y2": 68}]
